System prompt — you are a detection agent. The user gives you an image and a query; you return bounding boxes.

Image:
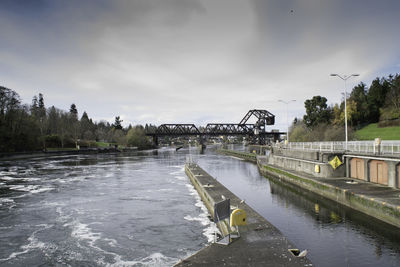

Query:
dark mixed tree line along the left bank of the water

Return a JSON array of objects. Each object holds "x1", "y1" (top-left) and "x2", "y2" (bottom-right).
[{"x1": 0, "y1": 86, "x2": 155, "y2": 152}]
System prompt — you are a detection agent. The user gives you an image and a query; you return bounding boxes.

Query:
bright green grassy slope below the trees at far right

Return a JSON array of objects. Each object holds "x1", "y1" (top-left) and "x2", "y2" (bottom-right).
[{"x1": 356, "y1": 123, "x2": 400, "y2": 140}]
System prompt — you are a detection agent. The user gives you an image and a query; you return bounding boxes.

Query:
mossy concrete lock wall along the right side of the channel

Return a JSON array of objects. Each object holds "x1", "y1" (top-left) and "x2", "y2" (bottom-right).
[{"x1": 221, "y1": 150, "x2": 400, "y2": 228}]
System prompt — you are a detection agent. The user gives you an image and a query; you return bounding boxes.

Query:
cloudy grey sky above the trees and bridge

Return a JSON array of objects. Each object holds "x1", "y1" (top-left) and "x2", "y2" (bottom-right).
[{"x1": 0, "y1": 0, "x2": 400, "y2": 130}]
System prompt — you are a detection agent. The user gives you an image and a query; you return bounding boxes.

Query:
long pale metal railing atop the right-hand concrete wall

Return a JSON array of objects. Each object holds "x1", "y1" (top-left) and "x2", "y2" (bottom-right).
[{"x1": 273, "y1": 141, "x2": 400, "y2": 156}]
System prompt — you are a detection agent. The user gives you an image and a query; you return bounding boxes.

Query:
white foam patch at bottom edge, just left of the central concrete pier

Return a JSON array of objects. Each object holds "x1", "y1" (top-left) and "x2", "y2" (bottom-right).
[{"x1": 107, "y1": 252, "x2": 178, "y2": 267}]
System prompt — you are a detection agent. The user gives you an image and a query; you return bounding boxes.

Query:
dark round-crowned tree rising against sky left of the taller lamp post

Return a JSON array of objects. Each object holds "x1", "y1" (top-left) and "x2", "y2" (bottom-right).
[{"x1": 303, "y1": 96, "x2": 332, "y2": 128}]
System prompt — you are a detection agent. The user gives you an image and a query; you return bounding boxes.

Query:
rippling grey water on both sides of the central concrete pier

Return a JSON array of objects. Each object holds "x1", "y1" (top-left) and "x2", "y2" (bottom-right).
[{"x1": 0, "y1": 149, "x2": 400, "y2": 266}]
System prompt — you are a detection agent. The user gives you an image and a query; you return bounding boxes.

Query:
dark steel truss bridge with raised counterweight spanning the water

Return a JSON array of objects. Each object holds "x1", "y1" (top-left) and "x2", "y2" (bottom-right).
[{"x1": 146, "y1": 109, "x2": 286, "y2": 145}]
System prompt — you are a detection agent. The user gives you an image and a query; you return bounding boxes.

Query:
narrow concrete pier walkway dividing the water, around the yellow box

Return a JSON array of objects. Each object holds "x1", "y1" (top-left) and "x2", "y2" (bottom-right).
[{"x1": 175, "y1": 164, "x2": 313, "y2": 267}]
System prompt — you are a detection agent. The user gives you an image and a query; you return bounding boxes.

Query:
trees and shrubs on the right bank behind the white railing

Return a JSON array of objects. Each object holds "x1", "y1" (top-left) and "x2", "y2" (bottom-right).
[{"x1": 290, "y1": 74, "x2": 400, "y2": 142}]
